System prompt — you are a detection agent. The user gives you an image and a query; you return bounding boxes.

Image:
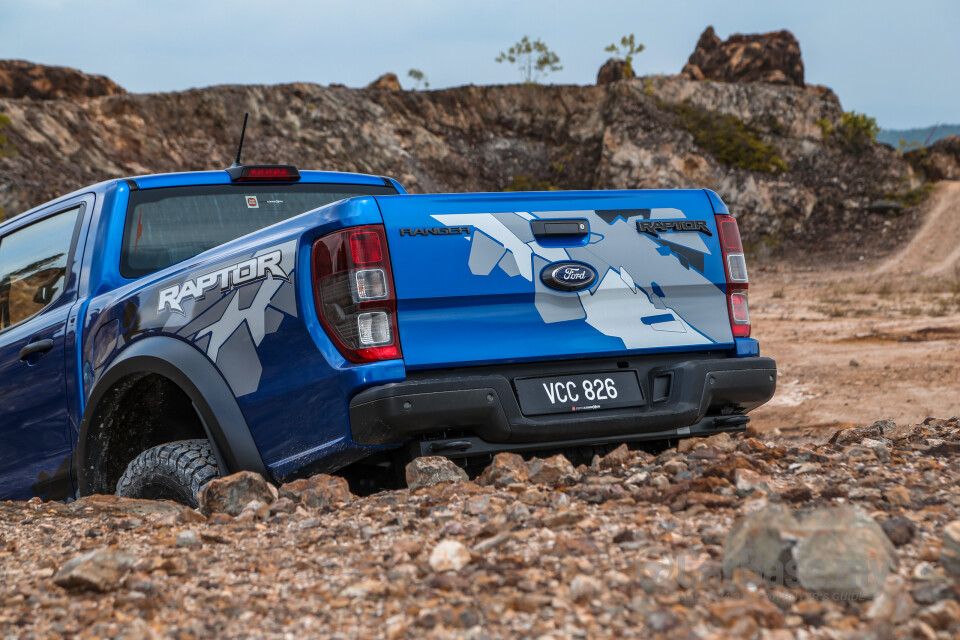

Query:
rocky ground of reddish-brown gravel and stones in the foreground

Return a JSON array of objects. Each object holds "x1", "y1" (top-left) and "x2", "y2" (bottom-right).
[{"x1": 0, "y1": 418, "x2": 960, "y2": 638}]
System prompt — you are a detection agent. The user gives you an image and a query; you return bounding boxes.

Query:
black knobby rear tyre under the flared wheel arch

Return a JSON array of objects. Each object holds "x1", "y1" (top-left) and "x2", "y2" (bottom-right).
[{"x1": 117, "y1": 440, "x2": 220, "y2": 509}]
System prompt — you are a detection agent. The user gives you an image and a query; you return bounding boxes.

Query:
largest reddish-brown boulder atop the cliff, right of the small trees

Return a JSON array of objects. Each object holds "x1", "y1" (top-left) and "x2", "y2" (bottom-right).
[{"x1": 680, "y1": 27, "x2": 804, "y2": 87}]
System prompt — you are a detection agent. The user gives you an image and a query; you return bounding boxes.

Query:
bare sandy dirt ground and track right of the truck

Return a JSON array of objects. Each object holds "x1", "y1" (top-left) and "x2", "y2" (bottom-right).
[{"x1": 750, "y1": 182, "x2": 960, "y2": 438}]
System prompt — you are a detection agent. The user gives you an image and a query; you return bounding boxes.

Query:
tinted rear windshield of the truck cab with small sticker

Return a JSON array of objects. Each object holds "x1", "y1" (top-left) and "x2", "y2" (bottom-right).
[{"x1": 120, "y1": 184, "x2": 397, "y2": 278}]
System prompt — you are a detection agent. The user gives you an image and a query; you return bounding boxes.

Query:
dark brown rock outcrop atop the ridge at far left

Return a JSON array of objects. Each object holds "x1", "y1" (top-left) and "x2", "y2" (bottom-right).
[{"x1": 0, "y1": 60, "x2": 126, "y2": 100}]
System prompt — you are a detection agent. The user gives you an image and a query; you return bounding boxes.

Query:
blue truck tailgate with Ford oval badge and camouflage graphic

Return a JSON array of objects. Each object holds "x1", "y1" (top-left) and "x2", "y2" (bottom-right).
[{"x1": 377, "y1": 190, "x2": 733, "y2": 368}]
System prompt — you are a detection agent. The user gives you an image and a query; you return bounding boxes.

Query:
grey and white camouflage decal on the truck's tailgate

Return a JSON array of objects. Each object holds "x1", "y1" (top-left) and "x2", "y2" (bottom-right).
[{"x1": 432, "y1": 208, "x2": 730, "y2": 349}]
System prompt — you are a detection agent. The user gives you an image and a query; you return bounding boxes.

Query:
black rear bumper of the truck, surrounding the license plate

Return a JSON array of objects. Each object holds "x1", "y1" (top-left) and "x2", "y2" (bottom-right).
[{"x1": 350, "y1": 353, "x2": 777, "y2": 455}]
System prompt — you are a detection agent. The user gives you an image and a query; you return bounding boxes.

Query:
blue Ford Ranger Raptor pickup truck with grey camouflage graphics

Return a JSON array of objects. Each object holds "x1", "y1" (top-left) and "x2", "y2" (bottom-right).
[{"x1": 0, "y1": 165, "x2": 776, "y2": 505}]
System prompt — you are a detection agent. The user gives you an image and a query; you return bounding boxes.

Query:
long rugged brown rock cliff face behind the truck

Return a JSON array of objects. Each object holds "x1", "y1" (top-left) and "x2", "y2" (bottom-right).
[{"x1": 0, "y1": 63, "x2": 918, "y2": 255}]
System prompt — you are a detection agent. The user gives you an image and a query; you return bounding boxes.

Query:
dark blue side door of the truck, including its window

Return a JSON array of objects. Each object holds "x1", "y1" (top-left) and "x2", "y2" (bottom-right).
[{"x1": 0, "y1": 205, "x2": 83, "y2": 500}]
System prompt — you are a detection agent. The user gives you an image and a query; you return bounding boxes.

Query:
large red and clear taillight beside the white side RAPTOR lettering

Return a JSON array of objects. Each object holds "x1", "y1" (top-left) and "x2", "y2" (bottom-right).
[{"x1": 313, "y1": 225, "x2": 402, "y2": 362}]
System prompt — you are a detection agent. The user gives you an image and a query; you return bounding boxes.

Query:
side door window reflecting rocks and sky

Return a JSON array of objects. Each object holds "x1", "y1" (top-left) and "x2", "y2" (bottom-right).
[{"x1": 0, "y1": 207, "x2": 80, "y2": 330}]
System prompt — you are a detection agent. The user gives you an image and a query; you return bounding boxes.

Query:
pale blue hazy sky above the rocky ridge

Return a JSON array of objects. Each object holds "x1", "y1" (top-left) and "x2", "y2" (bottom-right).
[{"x1": 0, "y1": 0, "x2": 960, "y2": 129}]
